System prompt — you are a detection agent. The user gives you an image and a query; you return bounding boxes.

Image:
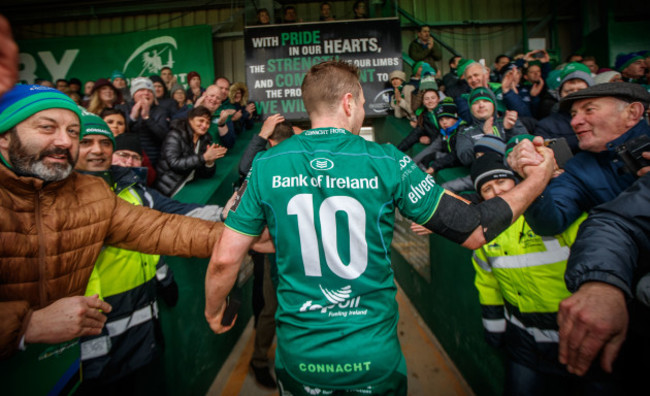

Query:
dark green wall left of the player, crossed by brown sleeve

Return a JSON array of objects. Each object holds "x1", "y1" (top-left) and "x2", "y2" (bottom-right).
[{"x1": 156, "y1": 124, "x2": 260, "y2": 395}]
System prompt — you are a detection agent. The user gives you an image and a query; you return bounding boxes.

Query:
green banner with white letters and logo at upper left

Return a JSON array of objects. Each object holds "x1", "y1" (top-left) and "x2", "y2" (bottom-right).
[{"x1": 18, "y1": 25, "x2": 214, "y2": 86}]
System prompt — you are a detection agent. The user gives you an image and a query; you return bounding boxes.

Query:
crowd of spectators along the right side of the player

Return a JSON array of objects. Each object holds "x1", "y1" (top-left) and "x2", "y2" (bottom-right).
[{"x1": 389, "y1": 36, "x2": 650, "y2": 395}]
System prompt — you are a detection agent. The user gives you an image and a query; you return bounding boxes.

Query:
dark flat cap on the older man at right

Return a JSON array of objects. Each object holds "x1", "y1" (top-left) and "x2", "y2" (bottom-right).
[{"x1": 560, "y1": 82, "x2": 650, "y2": 111}]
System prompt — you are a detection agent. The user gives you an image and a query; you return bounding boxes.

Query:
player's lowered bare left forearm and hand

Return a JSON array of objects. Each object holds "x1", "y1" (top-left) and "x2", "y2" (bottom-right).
[{"x1": 205, "y1": 228, "x2": 255, "y2": 334}]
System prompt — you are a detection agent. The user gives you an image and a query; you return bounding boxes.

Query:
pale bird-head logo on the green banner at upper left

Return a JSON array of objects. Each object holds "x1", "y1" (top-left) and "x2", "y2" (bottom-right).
[{"x1": 122, "y1": 36, "x2": 178, "y2": 77}]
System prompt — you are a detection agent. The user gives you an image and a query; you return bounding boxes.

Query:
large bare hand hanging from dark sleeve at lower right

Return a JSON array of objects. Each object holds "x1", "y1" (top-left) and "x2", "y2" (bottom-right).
[{"x1": 557, "y1": 282, "x2": 629, "y2": 375}]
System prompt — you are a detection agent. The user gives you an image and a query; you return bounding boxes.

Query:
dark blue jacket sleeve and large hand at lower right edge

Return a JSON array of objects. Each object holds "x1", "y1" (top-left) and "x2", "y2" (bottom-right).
[{"x1": 558, "y1": 173, "x2": 650, "y2": 394}]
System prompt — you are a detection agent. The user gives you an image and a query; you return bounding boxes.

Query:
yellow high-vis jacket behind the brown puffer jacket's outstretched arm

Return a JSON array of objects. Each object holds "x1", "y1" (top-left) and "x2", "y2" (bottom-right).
[{"x1": 81, "y1": 186, "x2": 164, "y2": 379}]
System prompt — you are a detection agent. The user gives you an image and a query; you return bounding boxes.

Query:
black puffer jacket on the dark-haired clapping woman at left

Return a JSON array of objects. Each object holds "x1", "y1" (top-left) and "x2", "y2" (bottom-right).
[{"x1": 154, "y1": 119, "x2": 216, "y2": 196}]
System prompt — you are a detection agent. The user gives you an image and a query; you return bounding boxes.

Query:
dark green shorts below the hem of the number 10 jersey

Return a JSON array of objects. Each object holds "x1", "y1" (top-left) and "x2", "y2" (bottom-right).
[{"x1": 275, "y1": 356, "x2": 408, "y2": 396}]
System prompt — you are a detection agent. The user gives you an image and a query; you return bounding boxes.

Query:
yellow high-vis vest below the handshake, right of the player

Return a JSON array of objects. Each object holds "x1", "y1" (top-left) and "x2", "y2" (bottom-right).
[{"x1": 472, "y1": 214, "x2": 587, "y2": 342}]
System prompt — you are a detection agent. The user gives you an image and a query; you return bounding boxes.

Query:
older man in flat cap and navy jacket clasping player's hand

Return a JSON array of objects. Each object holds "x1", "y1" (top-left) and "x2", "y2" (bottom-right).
[{"x1": 508, "y1": 83, "x2": 650, "y2": 236}]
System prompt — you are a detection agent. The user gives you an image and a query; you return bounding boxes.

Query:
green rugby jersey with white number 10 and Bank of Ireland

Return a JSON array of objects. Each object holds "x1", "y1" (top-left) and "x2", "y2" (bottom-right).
[{"x1": 226, "y1": 128, "x2": 443, "y2": 388}]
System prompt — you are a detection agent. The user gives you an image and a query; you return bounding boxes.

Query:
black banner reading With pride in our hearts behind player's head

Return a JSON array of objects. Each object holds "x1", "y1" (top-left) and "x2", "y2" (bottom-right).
[{"x1": 244, "y1": 18, "x2": 402, "y2": 120}]
